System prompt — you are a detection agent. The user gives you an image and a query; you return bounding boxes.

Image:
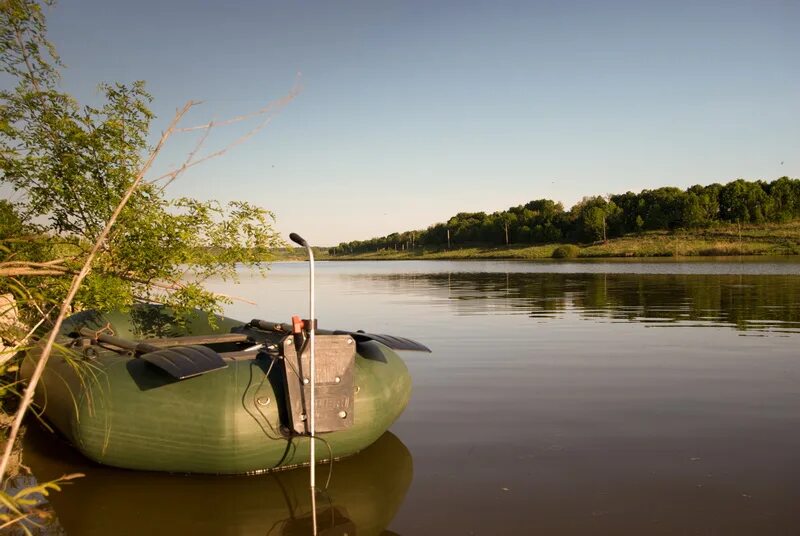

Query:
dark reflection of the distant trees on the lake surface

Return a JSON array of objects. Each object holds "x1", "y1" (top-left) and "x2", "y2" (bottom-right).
[{"x1": 356, "y1": 272, "x2": 800, "y2": 332}]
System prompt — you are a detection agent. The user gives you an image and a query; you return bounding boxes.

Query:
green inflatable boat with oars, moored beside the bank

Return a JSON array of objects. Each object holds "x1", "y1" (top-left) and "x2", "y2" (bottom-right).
[{"x1": 22, "y1": 306, "x2": 430, "y2": 474}]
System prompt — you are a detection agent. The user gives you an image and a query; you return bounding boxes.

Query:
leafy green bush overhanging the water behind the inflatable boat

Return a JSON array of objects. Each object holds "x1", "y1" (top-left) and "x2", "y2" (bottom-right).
[{"x1": 0, "y1": 0, "x2": 281, "y2": 332}]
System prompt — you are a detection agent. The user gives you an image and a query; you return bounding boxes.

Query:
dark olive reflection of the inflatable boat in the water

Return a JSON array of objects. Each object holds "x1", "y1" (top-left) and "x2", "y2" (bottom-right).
[{"x1": 24, "y1": 424, "x2": 413, "y2": 536}]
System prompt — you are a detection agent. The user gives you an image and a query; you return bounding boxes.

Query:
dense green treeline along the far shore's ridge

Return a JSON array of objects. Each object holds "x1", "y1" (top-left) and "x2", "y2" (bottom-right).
[{"x1": 330, "y1": 177, "x2": 800, "y2": 255}]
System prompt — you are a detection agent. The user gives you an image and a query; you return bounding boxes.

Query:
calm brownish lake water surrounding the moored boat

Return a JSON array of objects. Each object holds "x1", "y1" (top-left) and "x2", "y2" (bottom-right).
[{"x1": 21, "y1": 259, "x2": 800, "y2": 535}]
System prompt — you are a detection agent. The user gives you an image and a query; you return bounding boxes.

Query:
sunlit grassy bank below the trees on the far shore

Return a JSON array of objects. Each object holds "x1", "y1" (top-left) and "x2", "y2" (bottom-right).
[{"x1": 330, "y1": 220, "x2": 800, "y2": 260}]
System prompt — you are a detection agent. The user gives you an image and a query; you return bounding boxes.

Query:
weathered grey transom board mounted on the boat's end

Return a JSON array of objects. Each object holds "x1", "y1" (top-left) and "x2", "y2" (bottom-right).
[{"x1": 281, "y1": 335, "x2": 356, "y2": 434}]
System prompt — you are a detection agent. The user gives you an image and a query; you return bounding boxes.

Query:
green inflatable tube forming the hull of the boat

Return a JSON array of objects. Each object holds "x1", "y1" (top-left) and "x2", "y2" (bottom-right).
[{"x1": 23, "y1": 307, "x2": 411, "y2": 474}]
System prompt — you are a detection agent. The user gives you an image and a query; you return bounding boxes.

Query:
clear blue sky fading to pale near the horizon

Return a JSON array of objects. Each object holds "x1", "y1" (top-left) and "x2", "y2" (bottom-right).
[{"x1": 42, "y1": 0, "x2": 800, "y2": 245}]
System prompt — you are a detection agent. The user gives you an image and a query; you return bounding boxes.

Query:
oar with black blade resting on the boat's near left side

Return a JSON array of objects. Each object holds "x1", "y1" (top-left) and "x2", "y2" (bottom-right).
[{"x1": 78, "y1": 327, "x2": 228, "y2": 380}]
